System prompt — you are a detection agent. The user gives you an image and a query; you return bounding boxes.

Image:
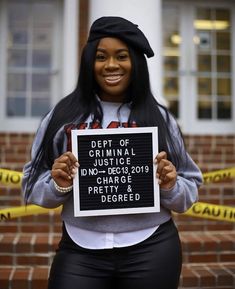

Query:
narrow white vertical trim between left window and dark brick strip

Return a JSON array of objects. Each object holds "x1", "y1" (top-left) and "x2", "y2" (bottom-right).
[{"x1": 62, "y1": 0, "x2": 79, "y2": 96}]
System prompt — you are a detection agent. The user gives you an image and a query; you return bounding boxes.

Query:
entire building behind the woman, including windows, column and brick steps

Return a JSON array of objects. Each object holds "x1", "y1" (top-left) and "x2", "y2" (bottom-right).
[{"x1": 0, "y1": 0, "x2": 235, "y2": 289}]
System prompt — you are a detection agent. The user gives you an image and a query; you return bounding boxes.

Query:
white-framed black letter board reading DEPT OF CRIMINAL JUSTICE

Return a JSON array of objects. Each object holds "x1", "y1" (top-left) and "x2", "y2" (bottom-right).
[{"x1": 72, "y1": 127, "x2": 160, "y2": 217}]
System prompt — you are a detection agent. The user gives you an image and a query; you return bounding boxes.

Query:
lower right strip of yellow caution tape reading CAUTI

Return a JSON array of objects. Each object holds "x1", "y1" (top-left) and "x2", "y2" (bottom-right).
[{"x1": 184, "y1": 202, "x2": 235, "y2": 222}]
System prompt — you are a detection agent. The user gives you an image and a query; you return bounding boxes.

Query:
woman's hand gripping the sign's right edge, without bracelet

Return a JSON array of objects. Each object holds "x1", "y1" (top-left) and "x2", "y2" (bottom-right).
[{"x1": 155, "y1": 151, "x2": 177, "y2": 190}]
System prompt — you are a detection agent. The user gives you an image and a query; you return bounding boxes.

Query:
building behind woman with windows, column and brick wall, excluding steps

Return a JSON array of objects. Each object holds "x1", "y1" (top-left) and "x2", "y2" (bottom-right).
[{"x1": 0, "y1": 0, "x2": 235, "y2": 228}]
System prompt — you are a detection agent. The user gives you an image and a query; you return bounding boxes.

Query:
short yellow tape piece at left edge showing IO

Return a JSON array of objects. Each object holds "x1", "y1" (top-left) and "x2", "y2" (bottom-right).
[{"x1": 0, "y1": 169, "x2": 23, "y2": 188}]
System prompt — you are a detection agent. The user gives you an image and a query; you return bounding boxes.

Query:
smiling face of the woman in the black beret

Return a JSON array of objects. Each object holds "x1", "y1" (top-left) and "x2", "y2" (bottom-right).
[{"x1": 94, "y1": 37, "x2": 131, "y2": 102}]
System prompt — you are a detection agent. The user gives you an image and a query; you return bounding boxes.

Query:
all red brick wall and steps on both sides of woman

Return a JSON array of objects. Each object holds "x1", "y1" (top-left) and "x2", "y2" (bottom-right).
[{"x1": 0, "y1": 133, "x2": 235, "y2": 289}]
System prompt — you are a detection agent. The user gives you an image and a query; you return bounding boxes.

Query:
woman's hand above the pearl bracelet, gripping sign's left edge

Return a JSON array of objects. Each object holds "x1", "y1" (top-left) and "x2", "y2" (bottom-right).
[{"x1": 51, "y1": 152, "x2": 79, "y2": 188}]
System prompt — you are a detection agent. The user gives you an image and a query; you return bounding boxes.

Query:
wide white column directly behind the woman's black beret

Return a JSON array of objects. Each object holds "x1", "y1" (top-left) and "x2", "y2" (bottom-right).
[{"x1": 89, "y1": 0, "x2": 165, "y2": 103}]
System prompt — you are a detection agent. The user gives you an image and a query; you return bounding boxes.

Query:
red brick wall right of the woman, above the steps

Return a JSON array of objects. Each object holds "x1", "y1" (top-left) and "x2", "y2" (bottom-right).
[{"x1": 173, "y1": 135, "x2": 235, "y2": 231}]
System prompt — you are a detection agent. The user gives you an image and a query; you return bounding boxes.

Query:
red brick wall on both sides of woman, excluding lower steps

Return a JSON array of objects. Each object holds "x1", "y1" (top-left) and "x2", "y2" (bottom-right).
[{"x1": 0, "y1": 133, "x2": 235, "y2": 232}]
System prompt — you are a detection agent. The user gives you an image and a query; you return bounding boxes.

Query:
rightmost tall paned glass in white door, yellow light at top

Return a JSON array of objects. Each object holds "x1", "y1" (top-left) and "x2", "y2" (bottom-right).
[{"x1": 194, "y1": 8, "x2": 232, "y2": 120}]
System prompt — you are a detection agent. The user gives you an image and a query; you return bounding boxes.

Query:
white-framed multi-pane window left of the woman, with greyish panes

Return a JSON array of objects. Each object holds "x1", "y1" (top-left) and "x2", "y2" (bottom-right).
[{"x1": 0, "y1": 0, "x2": 61, "y2": 130}]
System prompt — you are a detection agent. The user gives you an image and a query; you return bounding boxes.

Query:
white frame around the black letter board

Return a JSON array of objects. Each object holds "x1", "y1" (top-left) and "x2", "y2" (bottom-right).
[{"x1": 71, "y1": 127, "x2": 160, "y2": 217}]
